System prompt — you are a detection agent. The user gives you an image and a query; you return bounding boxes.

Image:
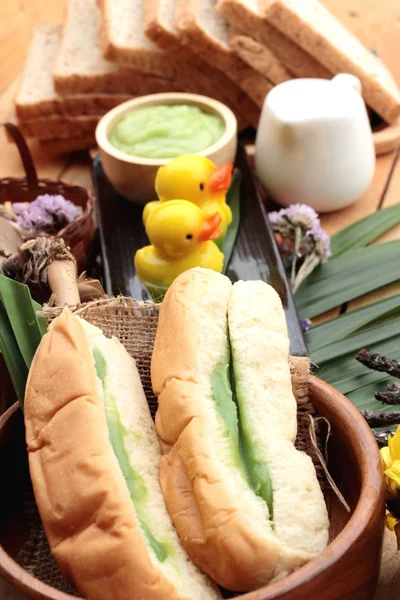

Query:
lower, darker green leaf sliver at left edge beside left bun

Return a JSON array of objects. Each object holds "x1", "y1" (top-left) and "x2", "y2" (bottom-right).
[{"x1": 0, "y1": 301, "x2": 28, "y2": 405}]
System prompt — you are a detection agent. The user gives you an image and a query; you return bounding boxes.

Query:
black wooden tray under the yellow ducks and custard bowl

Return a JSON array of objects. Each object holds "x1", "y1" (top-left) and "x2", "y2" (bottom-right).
[{"x1": 93, "y1": 146, "x2": 307, "y2": 356}]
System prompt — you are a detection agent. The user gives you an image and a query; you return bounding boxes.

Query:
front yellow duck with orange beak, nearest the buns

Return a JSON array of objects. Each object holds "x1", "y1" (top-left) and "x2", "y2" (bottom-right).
[{"x1": 135, "y1": 200, "x2": 224, "y2": 289}]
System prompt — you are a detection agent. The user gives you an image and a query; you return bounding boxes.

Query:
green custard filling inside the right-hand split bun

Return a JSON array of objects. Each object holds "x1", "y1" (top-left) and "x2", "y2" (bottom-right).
[{"x1": 211, "y1": 346, "x2": 273, "y2": 520}]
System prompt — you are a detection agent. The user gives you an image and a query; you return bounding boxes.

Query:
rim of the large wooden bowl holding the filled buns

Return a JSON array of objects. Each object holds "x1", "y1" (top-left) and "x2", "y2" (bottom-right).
[{"x1": 0, "y1": 376, "x2": 385, "y2": 600}]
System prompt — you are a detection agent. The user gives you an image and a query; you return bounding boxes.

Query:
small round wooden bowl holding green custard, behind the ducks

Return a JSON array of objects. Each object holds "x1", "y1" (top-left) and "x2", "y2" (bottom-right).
[{"x1": 96, "y1": 92, "x2": 237, "y2": 204}]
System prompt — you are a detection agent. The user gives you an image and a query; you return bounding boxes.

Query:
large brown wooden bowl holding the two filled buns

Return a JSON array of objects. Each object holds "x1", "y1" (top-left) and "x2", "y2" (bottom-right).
[{"x1": 0, "y1": 377, "x2": 384, "y2": 600}]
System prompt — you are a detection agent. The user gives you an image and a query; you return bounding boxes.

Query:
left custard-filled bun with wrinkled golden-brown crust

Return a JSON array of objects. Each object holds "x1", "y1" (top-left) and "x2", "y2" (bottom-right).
[{"x1": 25, "y1": 308, "x2": 220, "y2": 600}]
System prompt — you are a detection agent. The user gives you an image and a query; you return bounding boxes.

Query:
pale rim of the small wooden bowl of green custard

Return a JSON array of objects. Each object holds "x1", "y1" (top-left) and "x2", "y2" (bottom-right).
[{"x1": 95, "y1": 92, "x2": 237, "y2": 167}]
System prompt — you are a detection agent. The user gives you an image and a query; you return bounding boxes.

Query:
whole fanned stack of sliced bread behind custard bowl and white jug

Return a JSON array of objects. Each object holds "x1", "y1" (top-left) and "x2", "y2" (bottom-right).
[{"x1": 16, "y1": 0, "x2": 400, "y2": 151}]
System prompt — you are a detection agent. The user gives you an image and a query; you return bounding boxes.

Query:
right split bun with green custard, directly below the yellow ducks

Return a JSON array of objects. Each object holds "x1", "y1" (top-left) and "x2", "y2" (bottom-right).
[{"x1": 151, "y1": 269, "x2": 329, "y2": 591}]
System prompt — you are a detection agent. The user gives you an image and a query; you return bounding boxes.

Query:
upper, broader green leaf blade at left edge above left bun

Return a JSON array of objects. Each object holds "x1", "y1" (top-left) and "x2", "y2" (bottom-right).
[{"x1": 0, "y1": 275, "x2": 44, "y2": 369}]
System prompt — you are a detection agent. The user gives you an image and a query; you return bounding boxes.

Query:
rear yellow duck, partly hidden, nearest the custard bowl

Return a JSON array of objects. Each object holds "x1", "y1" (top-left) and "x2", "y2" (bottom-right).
[{"x1": 143, "y1": 154, "x2": 233, "y2": 239}]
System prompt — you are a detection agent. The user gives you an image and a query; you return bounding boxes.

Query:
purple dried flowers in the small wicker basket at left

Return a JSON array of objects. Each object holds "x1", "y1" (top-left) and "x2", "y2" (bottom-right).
[{"x1": 13, "y1": 194, "x2": 82, "y2": 233}]
